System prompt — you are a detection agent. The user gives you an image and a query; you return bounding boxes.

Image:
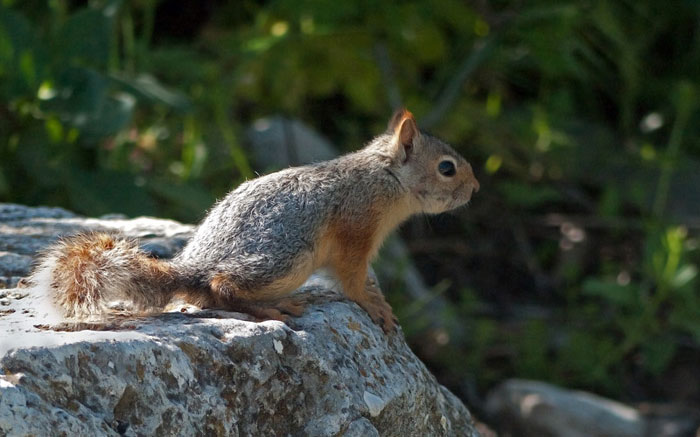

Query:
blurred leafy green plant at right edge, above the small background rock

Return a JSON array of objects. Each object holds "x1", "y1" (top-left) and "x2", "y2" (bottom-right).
[{"x1": 582, "y1": 227, "x2": 700, "y2": 378}]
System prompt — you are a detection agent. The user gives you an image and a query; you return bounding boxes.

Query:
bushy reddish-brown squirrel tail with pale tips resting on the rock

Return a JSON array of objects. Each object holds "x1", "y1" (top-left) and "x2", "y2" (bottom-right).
[{"x1": 30, "y1": 233, "x2": 184, "y2": 319}]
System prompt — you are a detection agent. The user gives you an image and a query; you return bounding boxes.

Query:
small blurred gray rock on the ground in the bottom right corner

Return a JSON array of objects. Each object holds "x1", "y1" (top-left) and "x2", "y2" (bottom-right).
[{"x1": 486, "y1": 379, "x2": 700, "y2": 437}]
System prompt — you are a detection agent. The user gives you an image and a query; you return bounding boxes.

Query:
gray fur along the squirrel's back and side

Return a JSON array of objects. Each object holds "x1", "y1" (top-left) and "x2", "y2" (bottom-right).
[{"x1": 175, "y1": 135, "x2": 405, "y2": 289}]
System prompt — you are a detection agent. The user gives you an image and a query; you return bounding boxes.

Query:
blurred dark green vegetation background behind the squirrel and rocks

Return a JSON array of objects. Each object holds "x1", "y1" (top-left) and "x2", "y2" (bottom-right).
[{"x1": 0, "y1": 0, "x2": 700, "y2": 432}]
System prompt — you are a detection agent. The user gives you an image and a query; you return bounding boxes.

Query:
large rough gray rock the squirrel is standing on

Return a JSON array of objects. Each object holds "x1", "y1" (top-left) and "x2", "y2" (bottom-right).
[{"x1": 0, "y1": 205, "x2": 478, "y2": 436}]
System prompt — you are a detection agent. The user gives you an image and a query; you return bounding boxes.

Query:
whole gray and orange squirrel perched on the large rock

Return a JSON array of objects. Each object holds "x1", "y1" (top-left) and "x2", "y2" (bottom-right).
[{"x1": 29, "y1": 109, "x2": 479, "y2": 332}]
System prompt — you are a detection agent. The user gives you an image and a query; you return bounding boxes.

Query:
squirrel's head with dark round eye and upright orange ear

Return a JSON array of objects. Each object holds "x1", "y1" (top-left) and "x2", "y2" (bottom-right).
[{"x1": 388, "y1": 109, "x2": 479, "y2": 213}]
